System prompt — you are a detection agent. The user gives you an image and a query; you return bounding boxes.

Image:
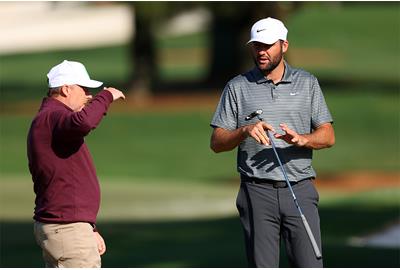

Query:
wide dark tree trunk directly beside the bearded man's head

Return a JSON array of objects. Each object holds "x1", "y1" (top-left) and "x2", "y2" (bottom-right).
[{"x1": 207, "y1": 2, "x2": 286, "y2": 87}]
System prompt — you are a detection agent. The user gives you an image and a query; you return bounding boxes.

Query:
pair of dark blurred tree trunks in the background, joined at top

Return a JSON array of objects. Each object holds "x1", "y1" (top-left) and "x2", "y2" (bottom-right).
[{"x1": 129, "y1": 1, "x2": 301, "y2": 96}]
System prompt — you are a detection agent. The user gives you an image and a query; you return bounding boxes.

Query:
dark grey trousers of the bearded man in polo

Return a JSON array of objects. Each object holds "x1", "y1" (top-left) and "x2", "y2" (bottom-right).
[{"x1": 236, "y1": 177, "x2": 323, "y2": 268}]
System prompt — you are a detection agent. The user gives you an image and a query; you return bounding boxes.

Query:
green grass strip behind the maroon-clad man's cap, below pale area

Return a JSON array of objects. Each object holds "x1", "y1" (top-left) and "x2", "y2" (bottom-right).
[{"x1": 0, "y1": 46, "x2": 130, "y2": 102}]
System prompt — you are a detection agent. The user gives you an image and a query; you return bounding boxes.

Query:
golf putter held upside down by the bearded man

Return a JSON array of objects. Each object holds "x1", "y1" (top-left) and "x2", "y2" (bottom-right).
[{"x1": 245, "y1": 110, "x2": 322, "y2": 259}]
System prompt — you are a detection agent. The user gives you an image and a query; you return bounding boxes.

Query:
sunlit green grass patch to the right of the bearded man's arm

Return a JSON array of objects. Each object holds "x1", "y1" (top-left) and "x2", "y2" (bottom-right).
[{"x1": 313, "y1": 87, "x2": 400, "y2": 172}]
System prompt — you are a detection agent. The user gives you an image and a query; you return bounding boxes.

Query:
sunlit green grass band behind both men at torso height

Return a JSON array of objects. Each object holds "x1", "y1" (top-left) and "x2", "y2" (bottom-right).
[{"x1": 0, "y1": 89, "x2": 400, "y2": 182}]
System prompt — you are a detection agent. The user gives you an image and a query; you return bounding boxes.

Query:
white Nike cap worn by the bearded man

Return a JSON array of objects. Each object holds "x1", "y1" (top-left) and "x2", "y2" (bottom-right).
[{"x1": 247, "y1": 17, "x2": 288, "y2": 45}]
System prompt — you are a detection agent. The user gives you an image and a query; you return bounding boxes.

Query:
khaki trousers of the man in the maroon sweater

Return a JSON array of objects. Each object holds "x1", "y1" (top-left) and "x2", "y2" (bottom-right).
[{"x1": 34, "y1": 221, "x2": 101, "y2": 268}]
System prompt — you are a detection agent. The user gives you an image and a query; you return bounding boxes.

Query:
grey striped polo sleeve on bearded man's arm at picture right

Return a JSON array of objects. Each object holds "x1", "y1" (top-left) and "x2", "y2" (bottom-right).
[{"x1": 311, "y1": 77, "x2": 333, "y2": 129}]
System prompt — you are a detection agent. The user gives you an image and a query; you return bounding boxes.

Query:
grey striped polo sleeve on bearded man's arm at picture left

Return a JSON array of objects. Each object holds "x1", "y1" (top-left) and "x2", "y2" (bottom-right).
[{"x1": 210, "y1": 84, "x2": 238, "y2": 130}]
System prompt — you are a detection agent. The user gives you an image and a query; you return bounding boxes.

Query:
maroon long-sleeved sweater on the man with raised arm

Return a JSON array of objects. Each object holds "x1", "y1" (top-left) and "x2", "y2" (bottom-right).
[{"x1": 27, "y1": 90, "x2": 113, "y2": 223}]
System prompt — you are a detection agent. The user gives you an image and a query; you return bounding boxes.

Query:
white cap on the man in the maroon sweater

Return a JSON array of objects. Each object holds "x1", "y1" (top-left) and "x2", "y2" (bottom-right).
[{"x1": 47, "y1": 60, "x2": 103, "y2": 88}]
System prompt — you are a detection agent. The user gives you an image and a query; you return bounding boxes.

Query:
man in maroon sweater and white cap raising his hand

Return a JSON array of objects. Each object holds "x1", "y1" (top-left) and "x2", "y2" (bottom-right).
[{"x1": 27, "y1": 60, "x2": 125, "y2": 268}]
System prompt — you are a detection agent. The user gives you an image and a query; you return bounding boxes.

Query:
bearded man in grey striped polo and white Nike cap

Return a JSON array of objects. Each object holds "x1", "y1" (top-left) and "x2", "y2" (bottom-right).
[{"x1": 211, "y1": 18, "x2": 335, "y2": 267}]
